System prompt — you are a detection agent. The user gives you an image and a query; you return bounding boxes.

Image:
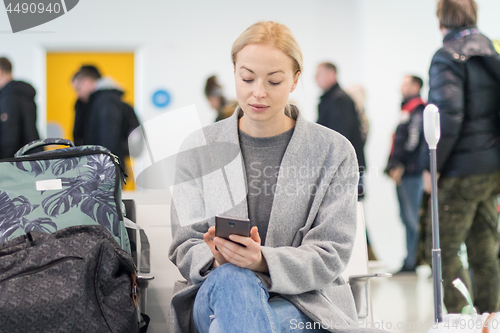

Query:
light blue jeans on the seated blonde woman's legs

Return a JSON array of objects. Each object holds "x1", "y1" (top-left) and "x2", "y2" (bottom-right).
[{"x1": 193, "y1": 264, "x2": 326, "y2": 333}]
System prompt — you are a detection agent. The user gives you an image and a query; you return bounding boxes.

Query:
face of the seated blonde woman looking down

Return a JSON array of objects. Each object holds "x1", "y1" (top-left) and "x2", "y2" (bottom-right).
[{"x1": 234, "y1": 44, "x2": 300, "y2": 122}]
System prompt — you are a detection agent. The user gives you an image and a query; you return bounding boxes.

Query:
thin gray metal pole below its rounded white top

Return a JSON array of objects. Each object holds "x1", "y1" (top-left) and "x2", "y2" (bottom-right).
[{"x1": 429, "y1": 149, "x2": 443, "y2": 323}]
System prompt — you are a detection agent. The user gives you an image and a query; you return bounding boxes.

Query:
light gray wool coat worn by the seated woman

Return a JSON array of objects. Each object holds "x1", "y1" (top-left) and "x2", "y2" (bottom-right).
[{"x1": 169, "y1": 106, "x2": 358, "y2": 332}]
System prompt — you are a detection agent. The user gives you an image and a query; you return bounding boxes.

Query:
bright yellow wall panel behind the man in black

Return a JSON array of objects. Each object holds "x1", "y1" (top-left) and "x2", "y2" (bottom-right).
[{"x1": 47, "y1": 52, "x2": 134, "y2": 190}]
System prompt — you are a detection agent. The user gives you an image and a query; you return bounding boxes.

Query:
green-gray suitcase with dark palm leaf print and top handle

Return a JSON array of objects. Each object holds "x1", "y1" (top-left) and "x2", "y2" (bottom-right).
[{"x1": 0, "y1": 138, "x2": 130, "y2": 254}]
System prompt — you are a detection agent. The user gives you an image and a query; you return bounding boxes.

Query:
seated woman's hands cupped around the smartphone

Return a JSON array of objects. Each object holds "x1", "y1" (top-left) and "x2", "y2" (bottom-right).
[{"x1": 204, "y1": 227, "x2": 269, "y2": 272}]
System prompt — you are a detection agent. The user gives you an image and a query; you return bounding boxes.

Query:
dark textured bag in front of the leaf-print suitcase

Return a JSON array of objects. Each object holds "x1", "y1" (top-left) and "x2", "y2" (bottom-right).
[{"x1": 0, "y1": 225, "x2": 139, "y2": 333}]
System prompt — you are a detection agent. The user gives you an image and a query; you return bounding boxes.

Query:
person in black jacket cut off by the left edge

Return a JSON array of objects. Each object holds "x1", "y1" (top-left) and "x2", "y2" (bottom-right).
[{"x1": 0, "y1": 57, "x2": 40, "y2": 158}]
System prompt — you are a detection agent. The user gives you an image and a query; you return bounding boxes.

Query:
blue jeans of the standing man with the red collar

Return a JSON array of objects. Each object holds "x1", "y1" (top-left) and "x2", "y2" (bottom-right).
[{"x1": 397, "y1": 174, "x2": 424, "y2": 269}]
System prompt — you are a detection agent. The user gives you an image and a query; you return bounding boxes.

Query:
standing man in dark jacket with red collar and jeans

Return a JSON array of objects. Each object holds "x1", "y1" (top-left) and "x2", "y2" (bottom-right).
[{"x1": 385, "y1": 75, "x2": 425, "y2": 273}]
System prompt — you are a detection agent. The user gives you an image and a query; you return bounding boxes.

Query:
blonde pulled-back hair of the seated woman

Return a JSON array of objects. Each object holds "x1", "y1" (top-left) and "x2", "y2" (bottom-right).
[{"x1": 231, "y1": 21, "x2": 303, "y2": 74}]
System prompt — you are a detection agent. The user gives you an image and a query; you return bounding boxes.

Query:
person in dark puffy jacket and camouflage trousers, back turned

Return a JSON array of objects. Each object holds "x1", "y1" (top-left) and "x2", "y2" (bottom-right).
[{"x1": 424, "y1": 0, "x2": 500, "y2": 313}]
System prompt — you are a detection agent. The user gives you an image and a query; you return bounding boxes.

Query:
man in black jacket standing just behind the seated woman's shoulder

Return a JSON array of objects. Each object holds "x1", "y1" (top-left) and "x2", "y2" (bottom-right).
[{"x1": 316, "y1": 62, "x2": 366, "y2": 198}]
